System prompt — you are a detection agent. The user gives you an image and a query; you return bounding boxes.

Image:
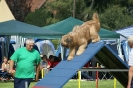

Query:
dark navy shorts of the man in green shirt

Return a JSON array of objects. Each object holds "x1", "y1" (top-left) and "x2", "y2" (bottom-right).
[{"x1": 14, "y1": 77, "x2": 33, "y2": 88}]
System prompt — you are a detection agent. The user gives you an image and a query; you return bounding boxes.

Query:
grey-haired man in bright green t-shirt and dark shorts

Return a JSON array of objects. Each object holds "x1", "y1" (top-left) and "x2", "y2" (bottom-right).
[{"x1": 9, "y1": 39, "x2": 41, "y2": 88}]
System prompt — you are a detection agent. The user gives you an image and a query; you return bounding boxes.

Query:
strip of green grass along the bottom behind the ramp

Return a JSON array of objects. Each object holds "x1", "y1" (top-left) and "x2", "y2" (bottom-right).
[{"x1": 0, "y1": 80, "x2": 124, "y2": 88}]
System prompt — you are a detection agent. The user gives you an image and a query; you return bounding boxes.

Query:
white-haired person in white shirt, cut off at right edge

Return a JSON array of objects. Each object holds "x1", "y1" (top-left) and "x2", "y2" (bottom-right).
[{"x1": 127, "y1": 36, "x2": 133, "y2": 88}]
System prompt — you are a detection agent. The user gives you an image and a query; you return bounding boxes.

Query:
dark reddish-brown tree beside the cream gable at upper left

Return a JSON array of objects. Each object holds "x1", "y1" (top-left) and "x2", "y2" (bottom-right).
[{"x1": 6, "y1": 0, "x2": 32, "y2": 21}]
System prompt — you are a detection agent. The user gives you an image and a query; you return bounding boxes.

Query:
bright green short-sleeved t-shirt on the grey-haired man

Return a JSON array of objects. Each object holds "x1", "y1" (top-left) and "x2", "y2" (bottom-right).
[{"x1": 11, "y1": 47, "x2": 41, "y2": 78}]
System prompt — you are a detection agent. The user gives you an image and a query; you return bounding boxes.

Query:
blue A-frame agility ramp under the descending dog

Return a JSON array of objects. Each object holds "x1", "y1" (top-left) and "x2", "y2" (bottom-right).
[{"x1": 33, "y1": 42, "x2": 128, "y2": 88}]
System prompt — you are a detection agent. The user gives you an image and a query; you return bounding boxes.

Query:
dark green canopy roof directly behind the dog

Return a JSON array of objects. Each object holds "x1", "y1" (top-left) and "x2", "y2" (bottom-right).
[{"x1": 43, "y1": 17, "x2": 120, "y2": 39}]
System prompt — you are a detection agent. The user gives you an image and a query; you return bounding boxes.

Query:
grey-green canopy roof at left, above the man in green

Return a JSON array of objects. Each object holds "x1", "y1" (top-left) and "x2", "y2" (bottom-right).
[{"x1": 0, "y1": 20, "x2": 63, "y2": 38}]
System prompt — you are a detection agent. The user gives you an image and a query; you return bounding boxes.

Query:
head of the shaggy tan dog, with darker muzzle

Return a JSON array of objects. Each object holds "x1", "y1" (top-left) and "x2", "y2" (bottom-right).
[{"x1": 61, "y1": 34, "x2": 73, "y2": 48}]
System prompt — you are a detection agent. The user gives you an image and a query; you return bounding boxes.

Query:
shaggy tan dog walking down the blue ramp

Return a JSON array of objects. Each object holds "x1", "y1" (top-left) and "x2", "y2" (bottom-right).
[{"x1": 61, "y1": 13, "x2": 100, "y2": 60}]
